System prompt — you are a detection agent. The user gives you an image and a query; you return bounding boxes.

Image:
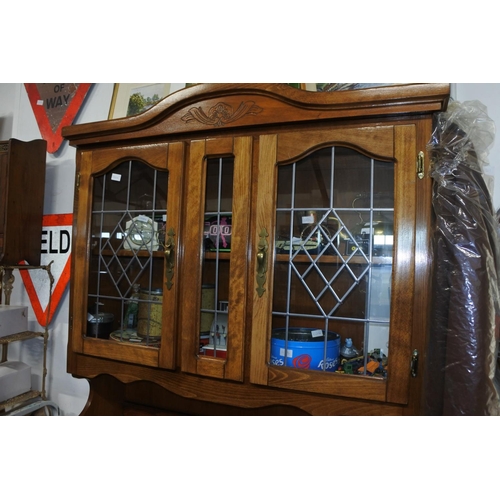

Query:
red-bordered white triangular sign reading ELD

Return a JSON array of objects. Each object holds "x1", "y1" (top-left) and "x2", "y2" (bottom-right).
[{"x1": 19, "y1": 214, "x2": 73, "y2": 327}]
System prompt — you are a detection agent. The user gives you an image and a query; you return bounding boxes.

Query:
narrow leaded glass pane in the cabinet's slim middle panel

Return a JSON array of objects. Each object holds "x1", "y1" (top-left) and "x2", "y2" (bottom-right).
[{"x1": 200, "y1": 158, "x2": 234, "y2": 359}]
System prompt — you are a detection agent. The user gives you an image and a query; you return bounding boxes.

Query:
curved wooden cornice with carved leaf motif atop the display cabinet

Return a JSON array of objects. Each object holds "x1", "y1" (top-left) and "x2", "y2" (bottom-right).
[{"x1": 63, "y1": 83, "x2": 450, "y2": 145}]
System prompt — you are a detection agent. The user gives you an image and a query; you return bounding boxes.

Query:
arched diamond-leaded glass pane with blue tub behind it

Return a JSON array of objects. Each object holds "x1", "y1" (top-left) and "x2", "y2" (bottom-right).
[{"x1": 270, "y1": 147, "x2": 394, "y2": 377}]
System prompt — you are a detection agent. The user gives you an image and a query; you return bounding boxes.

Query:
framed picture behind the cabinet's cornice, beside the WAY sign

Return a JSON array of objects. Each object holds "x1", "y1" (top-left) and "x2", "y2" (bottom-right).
[{"x1": 108, "y1": 83, "x2": 172, "y2": 120}]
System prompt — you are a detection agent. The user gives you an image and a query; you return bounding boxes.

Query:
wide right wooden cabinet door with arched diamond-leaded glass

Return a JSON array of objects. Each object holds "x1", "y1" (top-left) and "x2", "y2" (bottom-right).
[{"x1": 250, "y1": 125, "x2": 417, "y2": 402}]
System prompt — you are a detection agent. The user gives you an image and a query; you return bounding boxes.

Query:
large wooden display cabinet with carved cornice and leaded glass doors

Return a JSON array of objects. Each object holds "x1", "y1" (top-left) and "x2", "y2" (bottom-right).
[{"x1": 64, "y1": 84, "x2": 449, "y2": 415}]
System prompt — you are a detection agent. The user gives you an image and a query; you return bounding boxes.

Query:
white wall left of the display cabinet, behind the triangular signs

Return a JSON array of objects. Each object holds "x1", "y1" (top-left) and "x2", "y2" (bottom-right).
[{"x1": 0, "y1": 83, "x2": 113, "y2": 415}]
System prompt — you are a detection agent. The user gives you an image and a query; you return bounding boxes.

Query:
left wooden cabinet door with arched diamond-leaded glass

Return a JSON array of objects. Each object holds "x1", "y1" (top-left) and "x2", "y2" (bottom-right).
[{"x1": 68, "y1": 143, "x2": 183, "y2": 368}]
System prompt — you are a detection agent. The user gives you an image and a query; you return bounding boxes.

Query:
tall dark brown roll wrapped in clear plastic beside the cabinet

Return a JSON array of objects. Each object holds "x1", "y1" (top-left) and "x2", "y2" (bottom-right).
[{"x1": 423, "y1": 101, "x2": 500, "y2": 415}]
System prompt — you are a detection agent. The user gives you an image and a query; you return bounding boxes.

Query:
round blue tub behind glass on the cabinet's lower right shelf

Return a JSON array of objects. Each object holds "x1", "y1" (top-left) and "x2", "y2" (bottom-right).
[{"x1": 271, "y1": 328, "x2": 340, "y2": 372}]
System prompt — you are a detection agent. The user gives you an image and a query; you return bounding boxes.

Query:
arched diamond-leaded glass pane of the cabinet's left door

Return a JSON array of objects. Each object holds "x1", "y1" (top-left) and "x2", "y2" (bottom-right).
[{"x1": 87, "y1": 161, "x2": 168, "y2": 347}]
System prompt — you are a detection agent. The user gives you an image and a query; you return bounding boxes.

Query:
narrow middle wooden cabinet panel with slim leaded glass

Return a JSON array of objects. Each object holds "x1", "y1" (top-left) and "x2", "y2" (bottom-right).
[{"x1": 182, "y1": 137, "x2": 252, "y2": 380}]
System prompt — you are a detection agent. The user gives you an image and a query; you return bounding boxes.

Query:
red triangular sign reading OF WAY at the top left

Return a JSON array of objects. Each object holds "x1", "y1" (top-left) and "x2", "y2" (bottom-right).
[{"x1": 24, "y1": 83, "x2": 92, "y2": 153}]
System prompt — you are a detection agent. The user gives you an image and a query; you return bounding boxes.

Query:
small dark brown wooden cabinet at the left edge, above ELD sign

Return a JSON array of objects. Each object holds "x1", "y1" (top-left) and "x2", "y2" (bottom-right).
[{"x1": 0, "y1": 139, "x2": 47, "y2": 266}]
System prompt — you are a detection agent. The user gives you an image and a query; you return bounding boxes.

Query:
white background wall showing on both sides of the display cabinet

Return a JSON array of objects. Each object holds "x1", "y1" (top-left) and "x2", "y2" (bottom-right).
[{"x1": 0, "y1": 83, "x2": 500, "y2": 415}]
